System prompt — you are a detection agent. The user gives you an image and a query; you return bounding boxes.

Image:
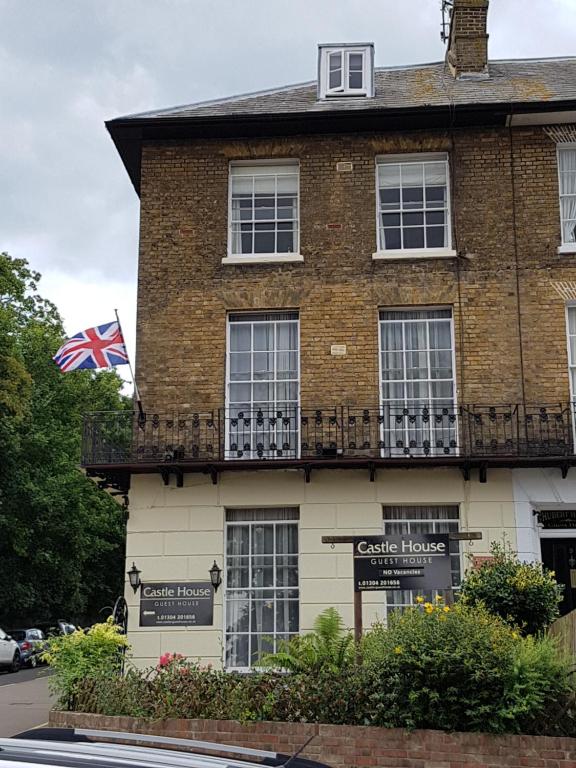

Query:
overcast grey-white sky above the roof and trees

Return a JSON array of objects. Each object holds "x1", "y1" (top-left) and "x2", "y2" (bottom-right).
[{"x1": 0, "y1": 0, "x2": 576, "y2": 384}]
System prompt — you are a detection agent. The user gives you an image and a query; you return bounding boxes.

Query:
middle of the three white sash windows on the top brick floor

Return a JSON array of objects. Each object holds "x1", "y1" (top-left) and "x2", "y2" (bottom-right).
[{"x1": 377, "y1": 154, "x2": 451, "y2": 251}]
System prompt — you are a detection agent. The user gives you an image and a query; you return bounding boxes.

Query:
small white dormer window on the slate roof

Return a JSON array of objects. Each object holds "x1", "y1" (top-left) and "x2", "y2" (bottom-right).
[{"x1": 318, "y1": 43, "x2": 374, "y2": 99}]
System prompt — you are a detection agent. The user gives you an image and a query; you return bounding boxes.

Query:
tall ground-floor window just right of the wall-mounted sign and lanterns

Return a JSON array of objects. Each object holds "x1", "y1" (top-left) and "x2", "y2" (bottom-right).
[{"x1": 224, "y1": 507, "x2": 300, "y2": 669}]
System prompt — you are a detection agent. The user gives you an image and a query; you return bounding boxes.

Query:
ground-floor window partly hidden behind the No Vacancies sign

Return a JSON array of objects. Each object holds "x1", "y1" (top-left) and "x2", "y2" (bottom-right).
[{"x1": 383, "y1": 504, "x2": 462, "y2": 613}]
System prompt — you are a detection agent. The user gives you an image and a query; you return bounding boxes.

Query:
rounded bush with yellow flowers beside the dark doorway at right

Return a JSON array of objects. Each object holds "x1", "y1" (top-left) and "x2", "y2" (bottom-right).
[{"x1": 460, "y1": 543, "x2": 562, "y2": 635}]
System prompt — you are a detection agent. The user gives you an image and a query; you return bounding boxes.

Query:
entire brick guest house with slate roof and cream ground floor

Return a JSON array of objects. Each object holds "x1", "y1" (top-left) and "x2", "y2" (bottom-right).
[{"x1": 83, "y1": 0, "x2": 576, "y2": 668}]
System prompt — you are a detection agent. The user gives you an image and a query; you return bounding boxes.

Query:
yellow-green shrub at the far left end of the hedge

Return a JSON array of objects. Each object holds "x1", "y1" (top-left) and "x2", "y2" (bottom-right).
[{"x1": 43, "y1": 618, "x2": 129, "y2": 707}]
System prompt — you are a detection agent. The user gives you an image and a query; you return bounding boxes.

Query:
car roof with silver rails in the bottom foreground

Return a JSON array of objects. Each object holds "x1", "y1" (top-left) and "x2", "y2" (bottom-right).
[{"x1": 0, "y1": 728, "x2": 328, "y2": 768}]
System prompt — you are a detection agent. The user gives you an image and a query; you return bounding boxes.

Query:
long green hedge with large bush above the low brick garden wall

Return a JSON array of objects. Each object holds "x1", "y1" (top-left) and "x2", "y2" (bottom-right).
[{"x1": 68, "y1": 603, "x2": 576, "y2": 736}]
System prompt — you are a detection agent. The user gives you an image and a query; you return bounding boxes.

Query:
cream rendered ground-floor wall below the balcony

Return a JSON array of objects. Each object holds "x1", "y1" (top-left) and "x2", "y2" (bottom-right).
[{"x1": 126, "y1": 469, "x2": 516, "y2": 666}]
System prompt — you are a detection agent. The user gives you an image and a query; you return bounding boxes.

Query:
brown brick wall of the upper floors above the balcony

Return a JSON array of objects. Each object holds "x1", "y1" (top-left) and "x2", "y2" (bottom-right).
[{"x1": 137, "y1": 124, "x2": 576, "y2": 411}]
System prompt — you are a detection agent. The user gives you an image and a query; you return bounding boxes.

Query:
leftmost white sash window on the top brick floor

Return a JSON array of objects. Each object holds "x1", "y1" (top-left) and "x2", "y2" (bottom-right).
[{"x1": 229, "y1": 162, "x2": 299, "y2": 257}]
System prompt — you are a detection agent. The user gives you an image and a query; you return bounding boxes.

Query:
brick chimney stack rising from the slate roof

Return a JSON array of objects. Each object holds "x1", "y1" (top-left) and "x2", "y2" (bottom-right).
[{"x1": 446, "y1": 0, "x2": 489, "y2": 79}]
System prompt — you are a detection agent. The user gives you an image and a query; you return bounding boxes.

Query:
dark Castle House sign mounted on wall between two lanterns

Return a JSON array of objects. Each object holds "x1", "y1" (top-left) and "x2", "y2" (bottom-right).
[{"x1": 140, "y1": 581, "x2": 214, "y2": 627}]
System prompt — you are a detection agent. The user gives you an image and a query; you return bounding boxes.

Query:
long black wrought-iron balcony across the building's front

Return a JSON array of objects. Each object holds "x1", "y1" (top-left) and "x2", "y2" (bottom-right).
[{"x1": 81, "y1": 403, "x2": 576, "y2": 489}]
